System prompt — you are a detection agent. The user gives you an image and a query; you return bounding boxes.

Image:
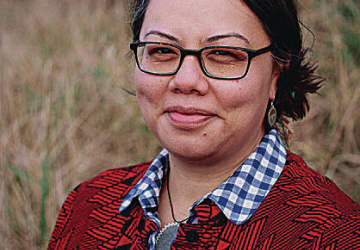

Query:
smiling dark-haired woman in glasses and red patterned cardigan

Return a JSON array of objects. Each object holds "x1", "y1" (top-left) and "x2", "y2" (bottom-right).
[{"x1": 49, "y1": 0, "x2": 360, "y2": 249}]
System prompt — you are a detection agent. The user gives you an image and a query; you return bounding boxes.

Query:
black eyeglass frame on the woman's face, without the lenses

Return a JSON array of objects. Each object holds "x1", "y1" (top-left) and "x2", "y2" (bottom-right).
[{"x1": 130, "y1": 41, "x2": 273, "y2": 80}]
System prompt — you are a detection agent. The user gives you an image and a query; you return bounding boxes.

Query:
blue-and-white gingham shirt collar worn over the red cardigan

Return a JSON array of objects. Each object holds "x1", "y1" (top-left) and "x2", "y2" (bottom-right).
[{"x1": 119, "y1": 129, "x2": 286, "y2": 248}]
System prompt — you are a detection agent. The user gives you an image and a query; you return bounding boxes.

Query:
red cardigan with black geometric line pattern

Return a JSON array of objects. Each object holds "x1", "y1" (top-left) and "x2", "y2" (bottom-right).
[{"x1": 48, "y1": 152, "x2": 360, "y2": 250}]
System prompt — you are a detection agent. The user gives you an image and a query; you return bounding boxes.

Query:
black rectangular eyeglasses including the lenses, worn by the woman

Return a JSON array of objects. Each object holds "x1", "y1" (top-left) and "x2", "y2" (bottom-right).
[{"x1": 130, "y1": 42, "x2": 272, "y2": 80}]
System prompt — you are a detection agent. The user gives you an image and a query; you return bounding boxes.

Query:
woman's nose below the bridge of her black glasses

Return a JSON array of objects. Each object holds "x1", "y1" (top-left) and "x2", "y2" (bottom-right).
[{"x1": 169, "y1": 55, "x2": 209, "y2": 95}]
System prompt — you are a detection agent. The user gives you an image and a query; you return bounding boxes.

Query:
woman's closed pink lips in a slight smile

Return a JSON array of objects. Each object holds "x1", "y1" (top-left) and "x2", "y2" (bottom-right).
[{"x1": 166, "y1": 107, "x2": 216, "y2": 129}]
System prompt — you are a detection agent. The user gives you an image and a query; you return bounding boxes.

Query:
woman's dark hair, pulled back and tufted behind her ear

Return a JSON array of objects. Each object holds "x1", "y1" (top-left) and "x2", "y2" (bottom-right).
[{"x1": 131, "y1": 0, "x2": 324, "y2": 136}]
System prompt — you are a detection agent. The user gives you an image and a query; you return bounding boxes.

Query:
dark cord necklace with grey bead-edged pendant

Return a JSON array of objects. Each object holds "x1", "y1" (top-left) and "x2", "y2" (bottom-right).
[{"x1": 155, "y1": 170, "x2": 190, "y2": 250}]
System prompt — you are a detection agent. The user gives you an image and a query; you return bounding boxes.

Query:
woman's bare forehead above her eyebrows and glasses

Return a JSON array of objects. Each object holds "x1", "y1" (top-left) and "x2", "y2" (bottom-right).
[{"x1": 140, "y1": 0, "x2": 269, "y2": 47}]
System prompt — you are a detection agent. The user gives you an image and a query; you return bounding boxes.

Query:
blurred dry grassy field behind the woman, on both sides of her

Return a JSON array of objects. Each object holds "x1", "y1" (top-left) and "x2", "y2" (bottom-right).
[{"x1": 0, "y1": 0, "x2": 360, "y2": 250}]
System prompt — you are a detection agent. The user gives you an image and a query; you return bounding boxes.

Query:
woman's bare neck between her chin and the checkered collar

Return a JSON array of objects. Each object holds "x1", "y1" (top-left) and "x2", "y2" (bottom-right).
[{"x1": 158, "y1": 131, "x2": 262, "y2": 226}]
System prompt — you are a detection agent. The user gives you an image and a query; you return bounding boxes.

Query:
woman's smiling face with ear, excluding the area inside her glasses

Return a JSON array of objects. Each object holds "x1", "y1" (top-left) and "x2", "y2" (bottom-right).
[{"x1": 135, "y1": 0, "x2": 278, "y2": 161}]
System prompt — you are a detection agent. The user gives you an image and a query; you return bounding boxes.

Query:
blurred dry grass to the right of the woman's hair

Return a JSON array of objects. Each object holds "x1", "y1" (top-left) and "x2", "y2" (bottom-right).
[{"x1": 292, "y1": 0, "x2": 360, "y2": 199}]
